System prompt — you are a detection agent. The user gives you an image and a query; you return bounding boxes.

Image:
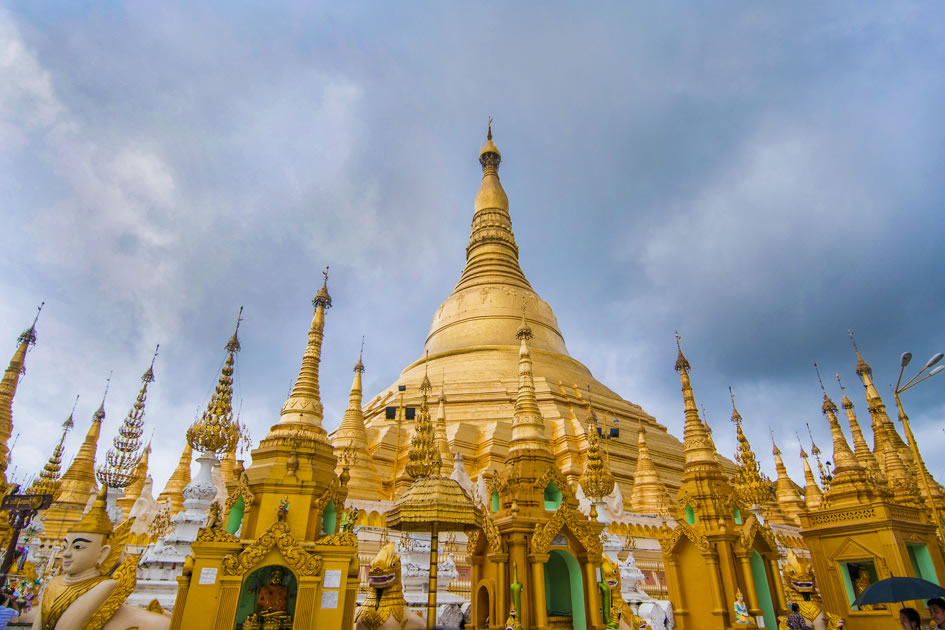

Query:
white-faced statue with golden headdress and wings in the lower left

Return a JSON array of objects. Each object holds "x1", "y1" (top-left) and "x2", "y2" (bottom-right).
[{"x1": 33, "y1": 485, "x2": 170, "y2": 630}]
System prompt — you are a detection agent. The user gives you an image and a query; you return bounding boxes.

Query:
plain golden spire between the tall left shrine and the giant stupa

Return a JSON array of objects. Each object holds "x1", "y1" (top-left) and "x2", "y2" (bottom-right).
[{"x1": 332, "y1": 342, "x2": 382, "y2": 501}]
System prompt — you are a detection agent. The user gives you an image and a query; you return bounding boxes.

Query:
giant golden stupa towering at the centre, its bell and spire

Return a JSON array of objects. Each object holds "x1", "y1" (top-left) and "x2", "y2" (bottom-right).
[{"x1": 344, "y1": 125, "x2": 692, "y2": 503}]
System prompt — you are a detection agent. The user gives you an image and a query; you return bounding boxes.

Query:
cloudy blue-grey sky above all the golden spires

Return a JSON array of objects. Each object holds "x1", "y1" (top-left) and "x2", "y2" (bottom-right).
[{"x1": 0, "y1": 1, "x2": 945, "y2": 498}]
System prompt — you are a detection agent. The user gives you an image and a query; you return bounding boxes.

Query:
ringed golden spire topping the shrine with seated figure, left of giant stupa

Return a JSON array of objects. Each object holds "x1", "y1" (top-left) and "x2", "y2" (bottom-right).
[{"x1": 269, "y1": 267, "x2": 331, "y2": 444}]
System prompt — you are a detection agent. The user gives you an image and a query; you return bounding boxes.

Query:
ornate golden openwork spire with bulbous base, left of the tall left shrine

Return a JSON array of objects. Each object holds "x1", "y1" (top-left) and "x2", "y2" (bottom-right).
[{"x1": 187, "y1": 314, "x2": 243, "y2": 455}]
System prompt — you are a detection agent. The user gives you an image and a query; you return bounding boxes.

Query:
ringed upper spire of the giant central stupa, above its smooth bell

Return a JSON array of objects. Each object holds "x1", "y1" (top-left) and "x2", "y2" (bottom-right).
[{"x1": 453, "y1": 118, "x2": 531, "y2": 293}]
